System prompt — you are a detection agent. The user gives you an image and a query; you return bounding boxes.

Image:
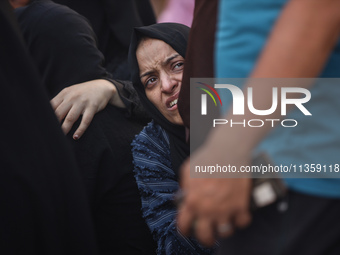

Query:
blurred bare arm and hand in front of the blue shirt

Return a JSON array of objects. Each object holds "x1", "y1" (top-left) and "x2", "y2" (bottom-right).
[{"x1": 178, "y1": 0, "x2": 340, "y2": 244}]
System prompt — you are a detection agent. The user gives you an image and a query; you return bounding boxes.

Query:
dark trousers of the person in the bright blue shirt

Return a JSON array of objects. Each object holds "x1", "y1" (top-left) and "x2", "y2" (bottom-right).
[{"x1": 218, "y1": 191, "x2": 340, "y2": 255}]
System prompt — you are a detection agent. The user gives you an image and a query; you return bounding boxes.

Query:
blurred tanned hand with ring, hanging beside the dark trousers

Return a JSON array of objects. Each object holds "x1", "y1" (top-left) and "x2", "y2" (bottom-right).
[{"x1": 177, "y1": 177, "x2": 251, "y2": 246}]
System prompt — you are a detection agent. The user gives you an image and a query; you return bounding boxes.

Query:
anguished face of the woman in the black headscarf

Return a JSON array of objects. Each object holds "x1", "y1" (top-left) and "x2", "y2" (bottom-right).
[{"x1": 136, "y1": 38, "x2": 184, "y2": 125}]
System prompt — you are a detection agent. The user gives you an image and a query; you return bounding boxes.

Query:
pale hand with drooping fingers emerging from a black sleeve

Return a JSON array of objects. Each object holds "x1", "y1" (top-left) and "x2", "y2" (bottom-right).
[{"x1": 51, "y1": 79, "x2": 123, "y2": 140}]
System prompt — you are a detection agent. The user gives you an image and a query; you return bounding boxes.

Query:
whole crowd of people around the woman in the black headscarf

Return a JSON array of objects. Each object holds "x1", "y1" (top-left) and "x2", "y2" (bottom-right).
[{"x1": 0, "y1": 0, "x2": 340, "y2": 255}]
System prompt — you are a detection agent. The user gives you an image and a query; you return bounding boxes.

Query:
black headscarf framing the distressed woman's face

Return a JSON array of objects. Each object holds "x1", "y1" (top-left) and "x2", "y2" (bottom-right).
[{"x1": 129, "y1": 23, "x2": 190, "y2": 176}]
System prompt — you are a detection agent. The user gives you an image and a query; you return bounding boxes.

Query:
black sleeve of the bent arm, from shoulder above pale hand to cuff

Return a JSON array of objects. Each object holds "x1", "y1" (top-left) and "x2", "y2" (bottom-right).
[{"x1": 15, "y1": 0, "x2": 147, "y2": 121}]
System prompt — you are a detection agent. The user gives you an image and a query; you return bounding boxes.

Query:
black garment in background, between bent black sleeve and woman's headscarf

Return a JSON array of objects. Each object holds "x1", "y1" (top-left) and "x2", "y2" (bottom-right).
[{"x1": 51, "y1": 0, "x2": 156, "y2": 80}]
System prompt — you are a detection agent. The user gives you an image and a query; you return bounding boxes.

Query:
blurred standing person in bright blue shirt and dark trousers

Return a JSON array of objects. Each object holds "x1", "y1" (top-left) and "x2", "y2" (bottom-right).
[{"x1": 178, "y1": 0, "x2": 340, "y2": 255}]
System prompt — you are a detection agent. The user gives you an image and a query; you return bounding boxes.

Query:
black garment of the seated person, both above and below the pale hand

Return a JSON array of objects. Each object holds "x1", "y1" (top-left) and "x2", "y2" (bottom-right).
[{"x1": 16, "y1": 0, "x2": 155, "y2": 255}]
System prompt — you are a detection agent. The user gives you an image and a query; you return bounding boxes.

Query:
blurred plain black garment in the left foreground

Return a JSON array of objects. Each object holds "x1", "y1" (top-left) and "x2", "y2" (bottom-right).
[{"x1": 0, "y1": 0, "x2": 97, "y2": 255}]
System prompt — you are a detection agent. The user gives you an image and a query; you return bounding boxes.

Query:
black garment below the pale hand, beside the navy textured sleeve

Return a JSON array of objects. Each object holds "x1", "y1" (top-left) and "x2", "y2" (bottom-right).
[{"x1": 68, "y1": 109, "x2": 156, "y2": 255}]
